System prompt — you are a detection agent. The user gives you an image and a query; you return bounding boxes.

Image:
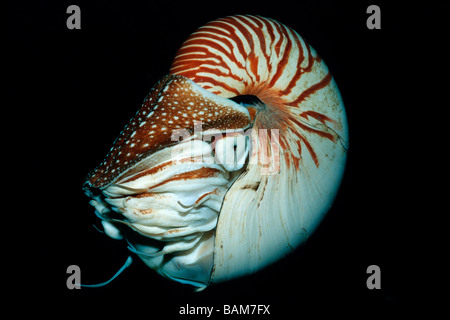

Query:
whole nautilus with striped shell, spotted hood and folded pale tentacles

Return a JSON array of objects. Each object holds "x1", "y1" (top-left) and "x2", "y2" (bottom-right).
[{"x1": 84, "y1": 15, "x2": 348, "y2": 288}]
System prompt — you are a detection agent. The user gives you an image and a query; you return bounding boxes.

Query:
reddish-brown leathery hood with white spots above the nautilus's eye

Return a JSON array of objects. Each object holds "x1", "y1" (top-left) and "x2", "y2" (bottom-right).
[{"x1": 86, "y1": 74, "x2": 250, "y2": 188}]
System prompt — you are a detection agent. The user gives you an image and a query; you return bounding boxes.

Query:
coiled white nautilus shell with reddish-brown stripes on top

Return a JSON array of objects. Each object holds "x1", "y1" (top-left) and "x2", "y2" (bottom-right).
[{"x1": 171, "y1": 15, "x2": 348, "y2": 282}]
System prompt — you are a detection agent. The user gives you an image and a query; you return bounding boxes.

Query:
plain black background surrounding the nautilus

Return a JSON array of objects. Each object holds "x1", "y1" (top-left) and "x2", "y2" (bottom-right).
[{"x1": 4, "y1": 0, "x2": 443, "y2": 318}]
